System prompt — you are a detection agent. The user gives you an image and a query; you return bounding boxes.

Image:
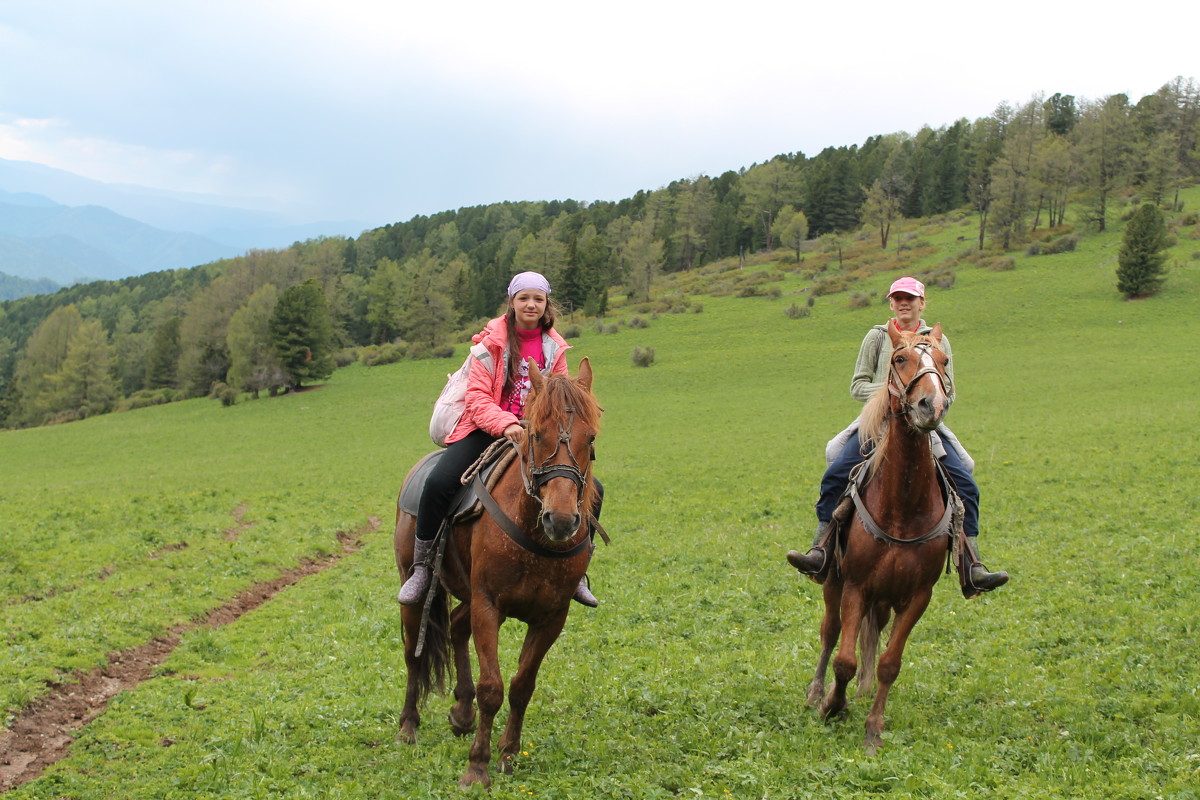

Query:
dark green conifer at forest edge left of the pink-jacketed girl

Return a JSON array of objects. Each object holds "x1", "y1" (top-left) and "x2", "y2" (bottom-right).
[{"x1": 270, "y1": 278, "x2": 334, "y2": 391}]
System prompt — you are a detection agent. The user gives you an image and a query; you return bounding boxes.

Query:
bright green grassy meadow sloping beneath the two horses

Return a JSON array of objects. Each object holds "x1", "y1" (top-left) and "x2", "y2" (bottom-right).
[{"x1": 0, "y1": 195, "x2": 1200, "y2": 800}]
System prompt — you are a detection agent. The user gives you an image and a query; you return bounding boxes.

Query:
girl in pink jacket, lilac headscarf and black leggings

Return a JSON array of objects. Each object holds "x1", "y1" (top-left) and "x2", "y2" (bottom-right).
[{"x1": 400, "y1": 272, "x2": 604, "y2": 608}]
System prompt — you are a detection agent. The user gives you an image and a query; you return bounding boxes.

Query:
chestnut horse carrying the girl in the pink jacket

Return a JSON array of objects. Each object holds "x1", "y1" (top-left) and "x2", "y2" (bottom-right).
[{"x1": 395, "y1": 359, "x2": 600, "y2": 787}]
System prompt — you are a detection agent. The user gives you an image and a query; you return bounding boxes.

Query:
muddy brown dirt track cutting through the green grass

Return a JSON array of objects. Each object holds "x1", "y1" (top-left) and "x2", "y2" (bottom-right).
[{"x1": 0, "y1": 516, "x2": 380, "y2": 794}]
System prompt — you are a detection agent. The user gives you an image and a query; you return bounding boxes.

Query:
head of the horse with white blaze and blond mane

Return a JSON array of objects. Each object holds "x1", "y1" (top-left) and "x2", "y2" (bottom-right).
[{"x1": 888, "y1": 323, "x2": 950, "y2": 432}]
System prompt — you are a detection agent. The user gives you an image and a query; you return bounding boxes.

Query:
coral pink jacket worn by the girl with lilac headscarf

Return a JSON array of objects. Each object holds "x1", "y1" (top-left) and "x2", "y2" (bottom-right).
[{"x1": 446, "y1": 317, "x2": 571, "y2": 444}]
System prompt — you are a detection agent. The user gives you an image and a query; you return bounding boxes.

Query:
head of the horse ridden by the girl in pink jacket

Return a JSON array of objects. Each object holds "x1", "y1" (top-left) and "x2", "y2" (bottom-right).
[{"x1": 524, "y1": 357, "x2": 600, "y2": 542}]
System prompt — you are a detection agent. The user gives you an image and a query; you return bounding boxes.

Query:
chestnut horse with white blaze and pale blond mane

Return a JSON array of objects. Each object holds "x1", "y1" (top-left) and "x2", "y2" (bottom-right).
[{"x1": 808, "y1": 325, "x2": 950, "y2": 753}]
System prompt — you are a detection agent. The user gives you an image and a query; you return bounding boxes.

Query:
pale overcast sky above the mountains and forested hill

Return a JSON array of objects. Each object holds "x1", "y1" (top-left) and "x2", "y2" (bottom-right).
[{"x1": 0, "y1": 0, "x2": 1200, "y2": 225}]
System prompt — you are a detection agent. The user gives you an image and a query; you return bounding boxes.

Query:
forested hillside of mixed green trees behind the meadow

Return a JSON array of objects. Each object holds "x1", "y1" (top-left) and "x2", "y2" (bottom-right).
[{"x1": 0, "y1": 78, "x2": 1200, "y2": 427}]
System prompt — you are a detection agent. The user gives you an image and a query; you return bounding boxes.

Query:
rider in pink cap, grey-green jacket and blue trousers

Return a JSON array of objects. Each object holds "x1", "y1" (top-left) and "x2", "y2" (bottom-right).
[{"x1": 787, "y1": 277, "x2": 1008, "y2": 591}]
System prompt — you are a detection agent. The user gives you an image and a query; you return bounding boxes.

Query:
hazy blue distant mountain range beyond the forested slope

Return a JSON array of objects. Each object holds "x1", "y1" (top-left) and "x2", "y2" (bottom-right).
[{"x1": 0, "y1": 158, "x2": 370, "y2": 300}]
